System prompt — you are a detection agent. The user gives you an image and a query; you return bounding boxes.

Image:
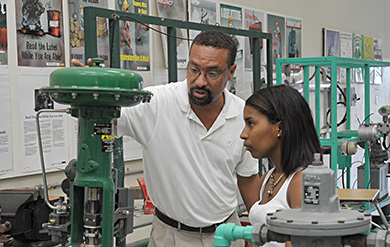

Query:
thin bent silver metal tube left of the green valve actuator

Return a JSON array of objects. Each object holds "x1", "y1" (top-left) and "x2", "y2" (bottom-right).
[{"x1": 35, "y1": 108, "x2": 70, "y2": 210}]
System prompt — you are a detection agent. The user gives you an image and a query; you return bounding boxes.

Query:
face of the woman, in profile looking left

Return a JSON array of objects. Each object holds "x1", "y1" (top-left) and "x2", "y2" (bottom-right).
[{"x1": 240, "y1": 106, "x2": 282, "y2": 160}]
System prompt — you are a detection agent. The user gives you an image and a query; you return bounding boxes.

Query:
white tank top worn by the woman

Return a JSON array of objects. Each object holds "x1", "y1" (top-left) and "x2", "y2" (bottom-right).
[{"x1": 249, "y1": 168, "x2": 302, "y2": 247}]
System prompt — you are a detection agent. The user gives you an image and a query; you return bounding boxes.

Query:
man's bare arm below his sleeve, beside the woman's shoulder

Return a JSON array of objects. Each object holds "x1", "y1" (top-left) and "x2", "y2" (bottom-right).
[{"x1": 237, "y1": 174, "x2": 260, "y2": 212}]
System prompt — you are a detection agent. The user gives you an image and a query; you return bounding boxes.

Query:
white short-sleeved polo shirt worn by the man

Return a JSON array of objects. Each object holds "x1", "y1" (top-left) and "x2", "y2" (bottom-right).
[{"x1": 117, "y1": 81, "x2": 258, "y2": 227}]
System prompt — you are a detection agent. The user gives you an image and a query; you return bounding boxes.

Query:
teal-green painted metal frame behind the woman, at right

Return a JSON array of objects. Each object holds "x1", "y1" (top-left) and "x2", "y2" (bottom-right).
[{"x1": 276, "y1": 57, "x2": 390, "y2": 188}]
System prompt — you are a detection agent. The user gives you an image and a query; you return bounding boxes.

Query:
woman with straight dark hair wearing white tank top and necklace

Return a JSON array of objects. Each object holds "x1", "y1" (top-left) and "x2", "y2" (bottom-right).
[{"x1": 240, "y1": 85, "x2": 321, "y2": 247}]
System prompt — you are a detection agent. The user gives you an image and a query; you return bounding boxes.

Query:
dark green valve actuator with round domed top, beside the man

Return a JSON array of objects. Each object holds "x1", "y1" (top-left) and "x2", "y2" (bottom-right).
[{"x1": 41, "y1": 58, "x2": 152, "y2": 247}]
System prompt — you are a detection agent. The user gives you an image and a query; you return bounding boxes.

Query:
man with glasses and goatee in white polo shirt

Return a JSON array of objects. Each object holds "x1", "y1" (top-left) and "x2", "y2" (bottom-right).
[{"x1": 74, "y1": 31, "x2": 259, "y2": 247}]
